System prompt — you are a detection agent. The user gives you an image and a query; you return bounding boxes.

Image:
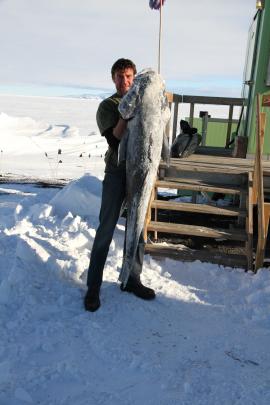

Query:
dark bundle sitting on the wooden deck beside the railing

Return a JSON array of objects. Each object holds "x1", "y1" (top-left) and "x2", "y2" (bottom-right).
[{"x1": 171, "y1": 120, "x2": 202, "y2": 158}]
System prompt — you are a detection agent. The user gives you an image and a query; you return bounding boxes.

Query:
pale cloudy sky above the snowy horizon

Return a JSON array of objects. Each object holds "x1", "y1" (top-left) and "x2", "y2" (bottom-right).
[{"x1": 0, "y1": 0, "x2": 256, "y2": 96}]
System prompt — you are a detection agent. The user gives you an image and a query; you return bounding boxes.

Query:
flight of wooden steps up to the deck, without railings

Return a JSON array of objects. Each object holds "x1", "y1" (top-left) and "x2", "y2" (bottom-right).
[{"x1": 145, "y1": 155, "x2": 253, "y2": 269}]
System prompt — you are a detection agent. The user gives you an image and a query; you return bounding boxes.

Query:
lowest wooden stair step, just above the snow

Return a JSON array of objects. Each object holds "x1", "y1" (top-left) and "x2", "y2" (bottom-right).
[{"x1": 145, "y1": 243, "x2": 247, "y2": 269}]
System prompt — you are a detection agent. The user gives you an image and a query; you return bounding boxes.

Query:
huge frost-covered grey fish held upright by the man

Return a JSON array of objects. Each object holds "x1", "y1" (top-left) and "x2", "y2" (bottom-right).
[{"x1": 119, "y1": 69, "x2": 170, "y2": 286}]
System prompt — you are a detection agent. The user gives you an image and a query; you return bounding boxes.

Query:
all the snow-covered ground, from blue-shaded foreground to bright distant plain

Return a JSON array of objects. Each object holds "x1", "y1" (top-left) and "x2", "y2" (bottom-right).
[{"x1": 0, "y1": 96, "x2": 270, "y2": 405}]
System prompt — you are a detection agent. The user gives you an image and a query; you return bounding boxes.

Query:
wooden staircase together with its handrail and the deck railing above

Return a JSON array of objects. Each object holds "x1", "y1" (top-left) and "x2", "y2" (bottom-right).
[{"x1": 145, "y1": 93, "x2": 270, "y2": 271}]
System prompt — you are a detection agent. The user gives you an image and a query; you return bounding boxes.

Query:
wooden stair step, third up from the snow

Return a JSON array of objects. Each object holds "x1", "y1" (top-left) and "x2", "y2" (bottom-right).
[{"x1": 151, "y1": 200, "x2": 246, "y2": 217}]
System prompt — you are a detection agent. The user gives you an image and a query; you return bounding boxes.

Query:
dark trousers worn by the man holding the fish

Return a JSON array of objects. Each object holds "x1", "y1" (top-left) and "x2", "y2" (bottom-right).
[{"x1": 87, "y1": 166, "x2": 145, "y2": 289}]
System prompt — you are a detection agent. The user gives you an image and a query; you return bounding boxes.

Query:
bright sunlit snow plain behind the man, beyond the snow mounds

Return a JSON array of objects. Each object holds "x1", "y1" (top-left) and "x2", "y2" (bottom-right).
[{"x1": 0, "y1": 95, "x2": 106, "y2": 179}]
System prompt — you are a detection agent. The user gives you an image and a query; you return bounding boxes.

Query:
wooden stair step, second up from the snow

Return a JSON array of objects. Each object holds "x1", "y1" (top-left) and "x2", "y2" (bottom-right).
[{"x1": 147, "y1": 221, "x2": 247, "y2": 241}]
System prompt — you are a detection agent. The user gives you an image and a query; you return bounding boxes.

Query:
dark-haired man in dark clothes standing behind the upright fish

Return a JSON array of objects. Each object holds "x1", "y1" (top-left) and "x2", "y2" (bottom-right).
[{"x1": 84, "y1": 58, "x2": 155, "y2": 312}]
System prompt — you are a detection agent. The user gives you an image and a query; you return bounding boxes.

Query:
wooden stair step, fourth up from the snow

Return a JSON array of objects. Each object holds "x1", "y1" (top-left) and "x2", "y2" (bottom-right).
[{"x1": 155, "y1": 178, "x2": 246, "y2": 195}]
